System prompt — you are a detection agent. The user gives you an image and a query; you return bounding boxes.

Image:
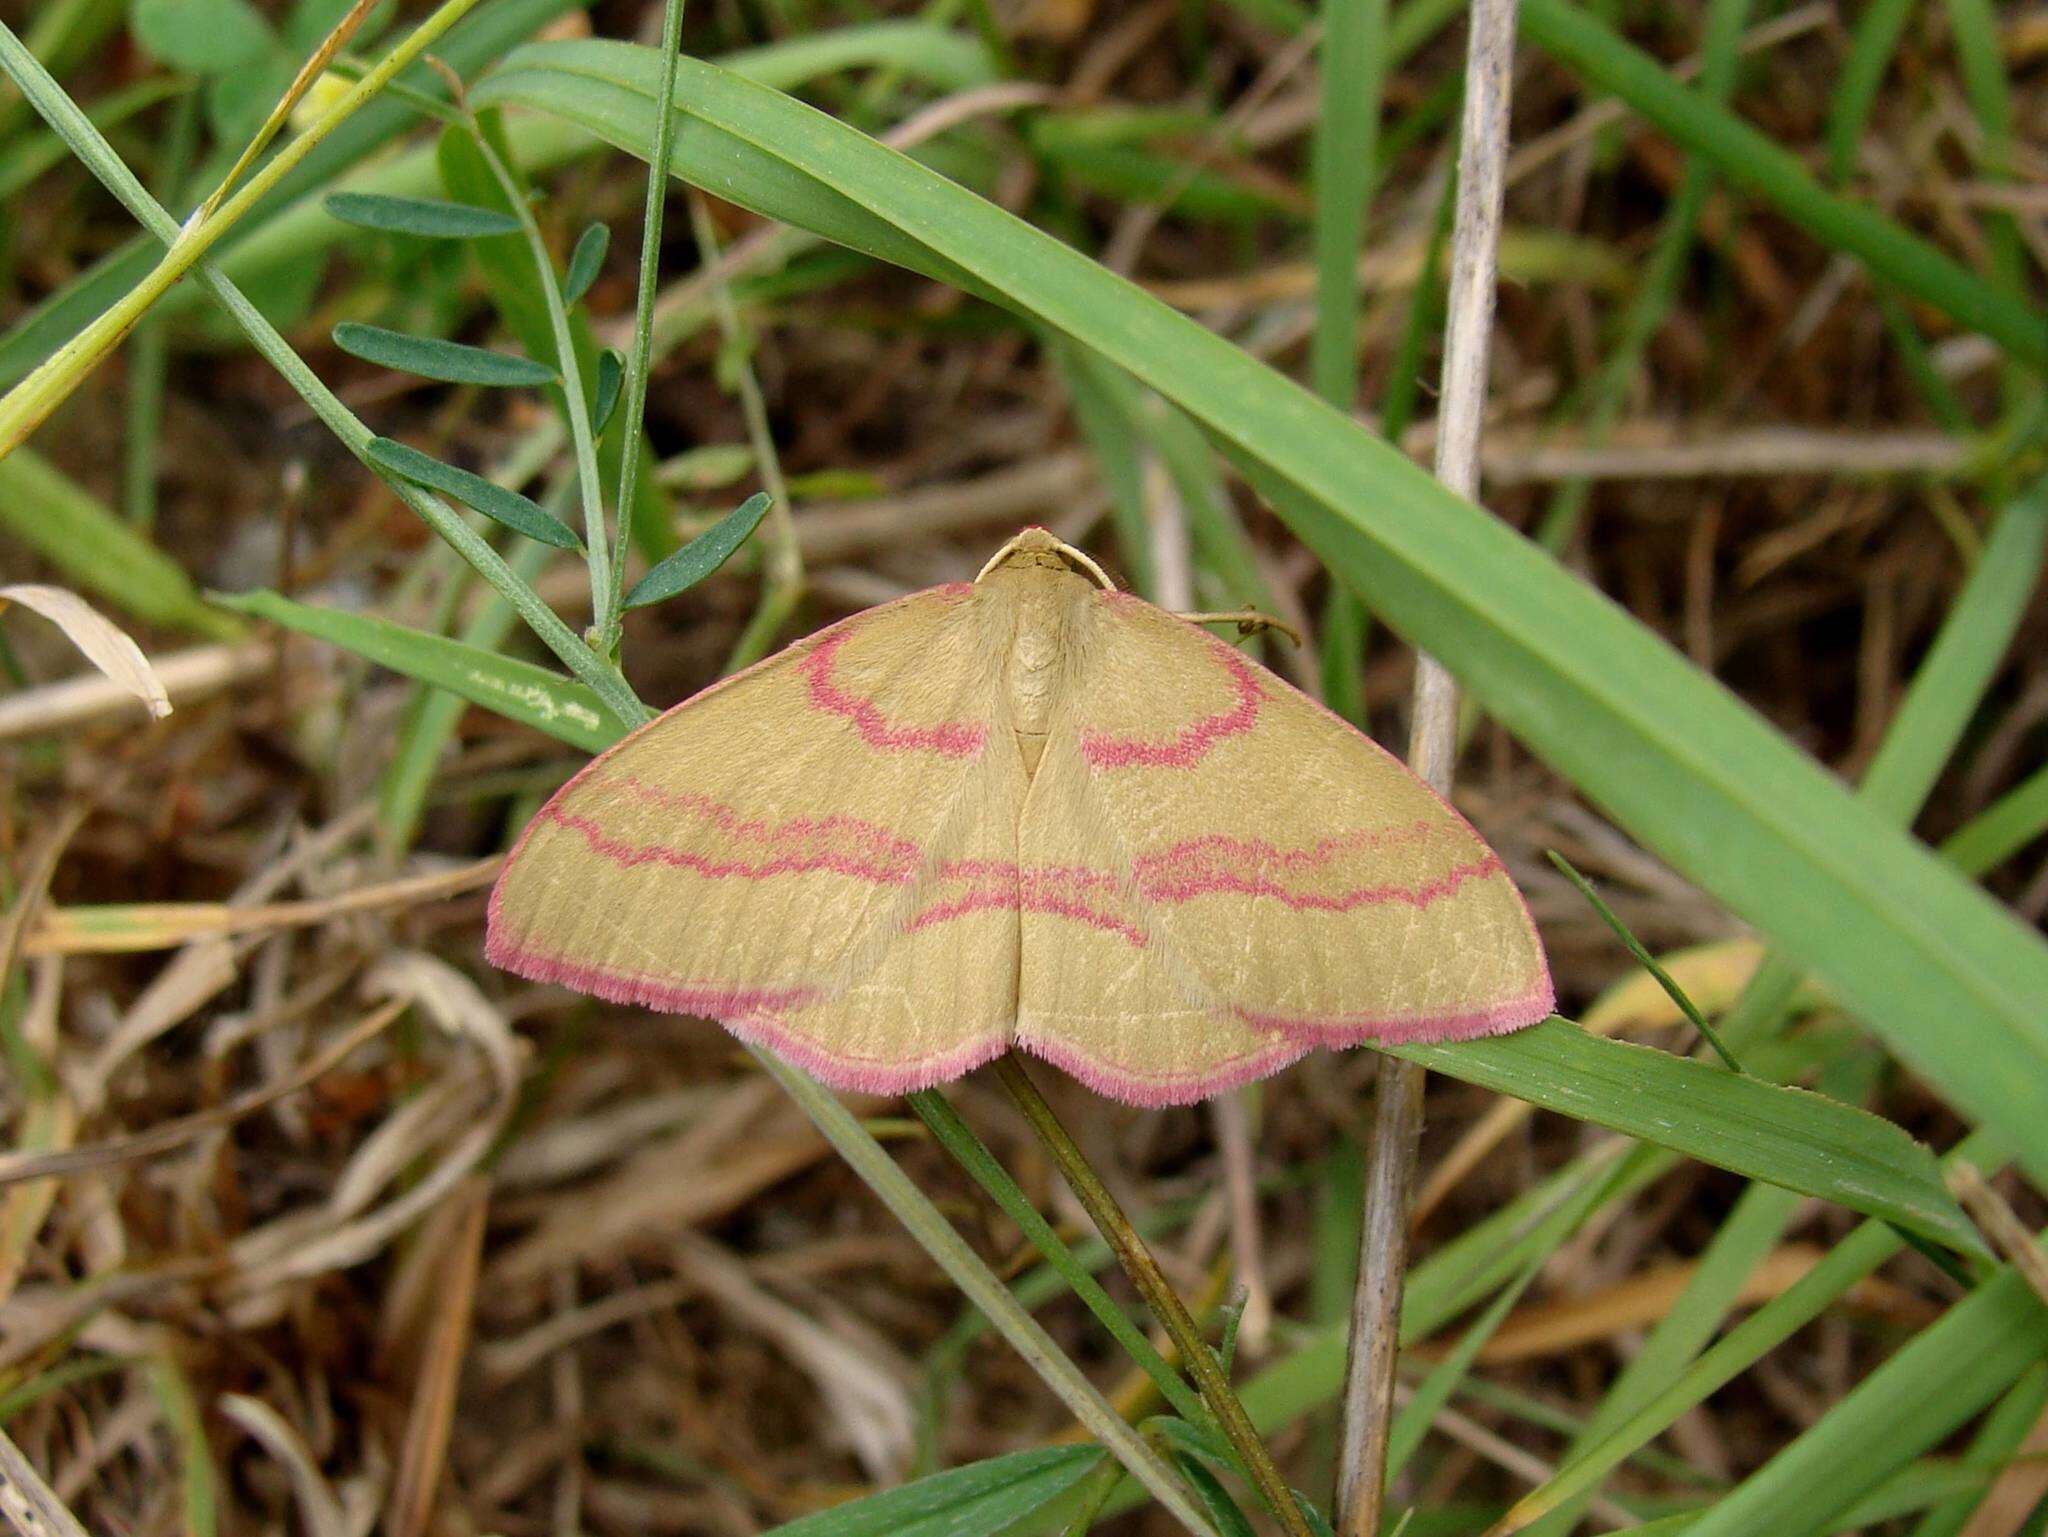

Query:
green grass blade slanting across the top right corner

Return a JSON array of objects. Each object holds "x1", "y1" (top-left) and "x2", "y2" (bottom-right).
[{"x1": 1522, "y1": 0, "x2": 2048, "y2": 369}]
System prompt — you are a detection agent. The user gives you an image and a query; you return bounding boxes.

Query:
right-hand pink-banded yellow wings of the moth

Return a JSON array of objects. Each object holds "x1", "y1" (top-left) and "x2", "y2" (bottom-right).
[{"x1": 1018, "y1": 592, "x2": 1552, "y2": 1098}]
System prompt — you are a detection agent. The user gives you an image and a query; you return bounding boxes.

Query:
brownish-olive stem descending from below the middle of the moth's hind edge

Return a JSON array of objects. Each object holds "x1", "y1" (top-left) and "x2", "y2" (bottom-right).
[{"x1": 995, "y1": 1051, "x2": 1311, "y2": 1537}]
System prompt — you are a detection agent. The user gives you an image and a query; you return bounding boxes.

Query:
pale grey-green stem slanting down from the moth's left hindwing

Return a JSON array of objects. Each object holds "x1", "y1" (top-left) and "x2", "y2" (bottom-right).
[{"x1": 750, "y1": 1047, "x2": 1220, "y2": 1537}]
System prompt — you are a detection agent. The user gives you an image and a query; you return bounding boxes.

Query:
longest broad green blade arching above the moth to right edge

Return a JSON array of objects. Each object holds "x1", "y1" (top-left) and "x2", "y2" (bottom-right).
[{"x1": 477, "y1": 43, "x2": 2048, "y2": 1176}]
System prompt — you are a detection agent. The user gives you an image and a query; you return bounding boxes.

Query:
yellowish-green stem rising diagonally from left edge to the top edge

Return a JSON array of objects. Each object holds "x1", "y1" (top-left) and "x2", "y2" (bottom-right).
[{"x1": 0, "y1": 0, "x2": 477, "y2": 455}]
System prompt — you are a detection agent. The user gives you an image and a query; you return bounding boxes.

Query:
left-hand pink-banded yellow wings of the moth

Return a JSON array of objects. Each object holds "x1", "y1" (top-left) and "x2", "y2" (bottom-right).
[{"x1": 487, "y1": 584, "x2": 1024, "y2": 1092}]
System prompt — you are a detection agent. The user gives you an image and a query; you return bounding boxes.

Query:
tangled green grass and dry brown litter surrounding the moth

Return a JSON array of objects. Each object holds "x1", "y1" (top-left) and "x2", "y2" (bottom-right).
[{"x1": 0, "y1": 0, "x2": 2048, "y2": 1537}]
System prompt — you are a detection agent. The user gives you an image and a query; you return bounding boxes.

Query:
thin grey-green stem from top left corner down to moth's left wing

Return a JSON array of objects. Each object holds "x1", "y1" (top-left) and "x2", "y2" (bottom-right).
[{"x1": 0, "y1": 23, "x2": 651, "y2": 725}]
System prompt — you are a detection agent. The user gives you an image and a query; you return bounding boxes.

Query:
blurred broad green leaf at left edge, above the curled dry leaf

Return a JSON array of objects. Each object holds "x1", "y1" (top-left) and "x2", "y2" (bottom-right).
[{"x1": 0, "y1": 445, "x2": 240, "y2": 635}]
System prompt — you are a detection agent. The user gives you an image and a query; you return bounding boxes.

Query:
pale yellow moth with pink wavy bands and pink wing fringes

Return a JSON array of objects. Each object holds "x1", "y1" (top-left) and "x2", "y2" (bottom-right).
[{"x1": 487, "y1": 529, "x2": 1552, "y2": 1105}]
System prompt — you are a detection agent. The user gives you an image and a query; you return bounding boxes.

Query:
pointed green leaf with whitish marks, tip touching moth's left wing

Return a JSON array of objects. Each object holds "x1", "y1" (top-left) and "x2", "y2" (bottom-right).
[{"x1": 213, "y1": 592, "x2": 625, "y2": 752}]
